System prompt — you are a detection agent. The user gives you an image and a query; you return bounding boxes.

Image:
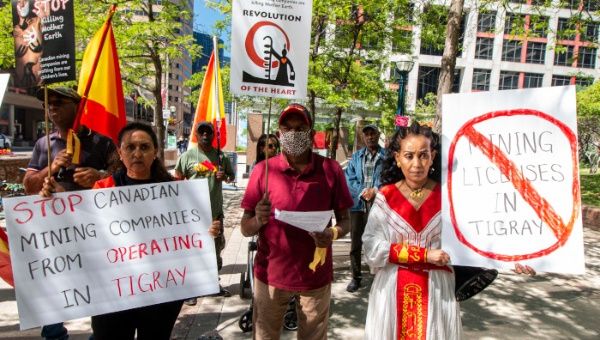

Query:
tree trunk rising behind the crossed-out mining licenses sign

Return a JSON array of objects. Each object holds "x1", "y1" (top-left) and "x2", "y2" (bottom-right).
[{"x1": 433, "y1": 0, "x2": 465, "y2": 133}]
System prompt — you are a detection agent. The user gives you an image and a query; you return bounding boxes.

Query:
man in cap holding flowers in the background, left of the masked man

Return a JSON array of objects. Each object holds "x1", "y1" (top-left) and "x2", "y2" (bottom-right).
[{"x1": 175, "y1": 121, "x2": 235, "y2": 306}]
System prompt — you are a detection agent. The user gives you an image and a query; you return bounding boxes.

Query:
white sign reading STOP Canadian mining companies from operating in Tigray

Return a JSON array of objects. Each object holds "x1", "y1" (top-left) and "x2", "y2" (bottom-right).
[{"x1": 4, "y1": 179, "x2": 219, "y2": 329}]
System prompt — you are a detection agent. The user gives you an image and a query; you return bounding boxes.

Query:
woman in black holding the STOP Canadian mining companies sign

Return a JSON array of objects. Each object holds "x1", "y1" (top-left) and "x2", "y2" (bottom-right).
[{"x1": 41, "y1": 123, "x2": 219, "y2": 340}]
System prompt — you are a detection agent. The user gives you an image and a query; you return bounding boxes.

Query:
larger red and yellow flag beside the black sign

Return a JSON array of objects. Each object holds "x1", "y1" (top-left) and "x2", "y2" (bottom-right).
[{"x1": 75, "y1": 7, "x2": 127, "y2": 144}]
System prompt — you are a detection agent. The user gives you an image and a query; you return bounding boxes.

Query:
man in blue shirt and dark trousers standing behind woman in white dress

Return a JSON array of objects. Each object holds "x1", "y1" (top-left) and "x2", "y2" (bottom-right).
[{"x1": 345, "y1": 124, "x2": 385, "y2": 293}]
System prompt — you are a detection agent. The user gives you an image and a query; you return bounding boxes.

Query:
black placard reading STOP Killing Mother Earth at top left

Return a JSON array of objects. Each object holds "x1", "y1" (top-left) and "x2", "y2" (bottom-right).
[{"x1": 11, "y1": 0, "x2": 75, "y2": 87}]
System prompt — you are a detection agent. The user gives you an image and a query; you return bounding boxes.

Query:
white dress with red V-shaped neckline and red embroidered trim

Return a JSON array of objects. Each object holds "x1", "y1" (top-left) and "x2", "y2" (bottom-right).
[{"x1": 362, "y1": 184, "x2": 463, "y2": 340}]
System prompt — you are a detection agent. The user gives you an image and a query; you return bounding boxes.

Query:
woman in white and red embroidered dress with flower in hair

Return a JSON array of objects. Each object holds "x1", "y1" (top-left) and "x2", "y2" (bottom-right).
[{"x1": 363, "y1": 123, "x2": 462, "y2": 339}]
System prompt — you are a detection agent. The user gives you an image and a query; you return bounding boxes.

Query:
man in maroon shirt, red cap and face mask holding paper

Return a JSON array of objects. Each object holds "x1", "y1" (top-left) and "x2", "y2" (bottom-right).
[{"x1": 241, "y1": 104, "x2": 352, "y2": 339}]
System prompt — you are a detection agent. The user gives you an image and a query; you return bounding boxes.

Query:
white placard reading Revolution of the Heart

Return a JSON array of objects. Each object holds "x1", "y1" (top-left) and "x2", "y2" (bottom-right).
[{"x1": 230, "y1": 0, "x2": 312, "y2": 99}]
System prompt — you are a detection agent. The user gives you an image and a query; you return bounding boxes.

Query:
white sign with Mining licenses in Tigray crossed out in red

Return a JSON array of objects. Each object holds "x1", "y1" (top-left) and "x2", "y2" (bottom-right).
[{"x1": 442, "y1": 86, "x2": 585, "y2": 274}]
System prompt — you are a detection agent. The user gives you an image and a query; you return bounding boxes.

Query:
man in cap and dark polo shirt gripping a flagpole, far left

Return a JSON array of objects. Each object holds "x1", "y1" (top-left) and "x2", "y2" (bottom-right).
[{"x1": 23, "y1": 87, "x2": 117, "y2": 339}]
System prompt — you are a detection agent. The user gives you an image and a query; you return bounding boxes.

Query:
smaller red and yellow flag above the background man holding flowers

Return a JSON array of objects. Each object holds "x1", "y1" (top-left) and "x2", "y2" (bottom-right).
[{"x1": 188, "y1": 39, "x2": 227, "y2": 149}]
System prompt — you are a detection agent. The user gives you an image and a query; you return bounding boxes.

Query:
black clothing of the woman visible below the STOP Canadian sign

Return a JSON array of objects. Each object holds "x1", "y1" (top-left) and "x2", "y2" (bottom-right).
[{"x1": 92, "y1": 301, "x2": 183, "y2": 340}]
